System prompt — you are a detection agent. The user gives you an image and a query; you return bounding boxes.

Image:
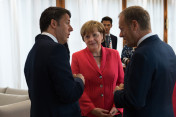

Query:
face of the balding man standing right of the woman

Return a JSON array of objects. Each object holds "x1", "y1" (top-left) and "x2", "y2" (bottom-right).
[{"x1": 119, "y1": 14, "x2": 137, "y2": 47}]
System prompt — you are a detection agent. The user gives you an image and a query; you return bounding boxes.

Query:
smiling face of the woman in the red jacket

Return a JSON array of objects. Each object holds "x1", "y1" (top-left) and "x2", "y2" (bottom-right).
[{"x1": 84, "y1": 28, "x2": 103, "y2": 52}]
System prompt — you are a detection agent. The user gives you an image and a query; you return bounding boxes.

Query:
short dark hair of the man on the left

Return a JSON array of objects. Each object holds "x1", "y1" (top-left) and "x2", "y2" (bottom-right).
[{"x1": 40, "y1": 7, "x2": 71, "y2": 32}]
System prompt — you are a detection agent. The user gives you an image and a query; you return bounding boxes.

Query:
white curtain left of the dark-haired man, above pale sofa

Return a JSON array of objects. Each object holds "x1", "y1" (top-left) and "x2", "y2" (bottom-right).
[{"x1": 0, "y1": 0, "x2": 56, "y2": 89}]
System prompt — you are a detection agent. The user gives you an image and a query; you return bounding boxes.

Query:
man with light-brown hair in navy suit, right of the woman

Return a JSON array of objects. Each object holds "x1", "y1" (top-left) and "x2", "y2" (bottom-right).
[{"x1": 114, "y1": 6, "x2": 176, "y2": 117}]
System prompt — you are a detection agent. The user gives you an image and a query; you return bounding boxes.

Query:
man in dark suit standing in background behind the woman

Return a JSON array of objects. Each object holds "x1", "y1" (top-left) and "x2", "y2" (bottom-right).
[{"x1": 101, "y1": 16, "x2": 117, "y2": 49}]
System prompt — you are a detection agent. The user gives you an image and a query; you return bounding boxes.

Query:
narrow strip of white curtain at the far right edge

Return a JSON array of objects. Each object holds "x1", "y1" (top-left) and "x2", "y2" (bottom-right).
[{"x1": 168, "y1": 0, "x2": 176, "y2": 53}]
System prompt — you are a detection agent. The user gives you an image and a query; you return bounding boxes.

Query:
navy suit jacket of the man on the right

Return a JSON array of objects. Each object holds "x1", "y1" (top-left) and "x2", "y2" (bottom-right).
[{"x1": 114, "y1": 35, "x2": 176, "y2": 117}]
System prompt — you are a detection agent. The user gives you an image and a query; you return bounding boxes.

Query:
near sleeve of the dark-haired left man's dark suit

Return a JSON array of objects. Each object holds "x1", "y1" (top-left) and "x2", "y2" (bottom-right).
[{"x1": 48, "y1": 45, "x2": 84, "y2": 103}]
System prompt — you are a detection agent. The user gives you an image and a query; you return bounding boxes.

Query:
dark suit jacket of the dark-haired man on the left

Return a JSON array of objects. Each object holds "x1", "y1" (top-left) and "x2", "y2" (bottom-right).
[{"x1": 24, "y1": 35, "x2": 84, "y2": 117}]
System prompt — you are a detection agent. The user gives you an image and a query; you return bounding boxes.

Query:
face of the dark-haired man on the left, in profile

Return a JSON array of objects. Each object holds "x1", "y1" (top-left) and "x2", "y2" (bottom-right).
[{"x1": 55, "y1": 14, "x2": 73, "y2": 44}]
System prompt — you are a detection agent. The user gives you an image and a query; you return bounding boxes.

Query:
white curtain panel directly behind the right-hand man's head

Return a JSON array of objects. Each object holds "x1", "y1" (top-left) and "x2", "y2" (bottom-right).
[{"x1": 127, "y1": 0, "x2": 164, "y2": 40}]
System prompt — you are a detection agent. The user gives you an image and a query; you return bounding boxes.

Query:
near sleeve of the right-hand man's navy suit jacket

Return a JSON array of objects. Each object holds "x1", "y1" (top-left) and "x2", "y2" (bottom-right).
[{"x1": 114, "y1": 53, "x2": 153, "y2": 109}]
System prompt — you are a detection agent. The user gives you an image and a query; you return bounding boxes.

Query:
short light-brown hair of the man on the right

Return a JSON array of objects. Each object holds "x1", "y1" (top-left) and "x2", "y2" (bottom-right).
[{"x1": 119, "y1": 6, "x2": 151, "y2": 30}]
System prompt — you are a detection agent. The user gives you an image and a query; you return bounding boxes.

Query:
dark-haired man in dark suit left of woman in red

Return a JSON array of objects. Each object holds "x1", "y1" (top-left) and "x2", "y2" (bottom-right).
[{"x1": 24, "y1": 7, "x2": 84, "y2": 117}]
